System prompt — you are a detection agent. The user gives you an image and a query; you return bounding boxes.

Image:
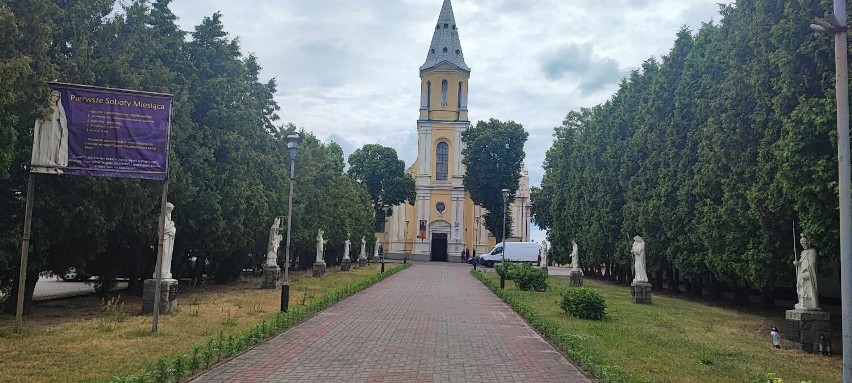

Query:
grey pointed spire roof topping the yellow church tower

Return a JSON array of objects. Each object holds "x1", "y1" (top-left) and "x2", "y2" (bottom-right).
[{"x1": 420, "y1": 0, "x2": 470, "y2": 71}]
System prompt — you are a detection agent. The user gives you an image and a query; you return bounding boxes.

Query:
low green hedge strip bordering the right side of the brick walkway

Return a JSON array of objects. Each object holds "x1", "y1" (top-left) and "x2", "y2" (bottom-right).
[{"x1": 471, "y1": 270, "x2": 633, "y2": 383}]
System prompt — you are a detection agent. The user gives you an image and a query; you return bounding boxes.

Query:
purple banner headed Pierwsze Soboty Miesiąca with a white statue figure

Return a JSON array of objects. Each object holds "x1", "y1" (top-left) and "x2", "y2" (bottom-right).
[{"x1": 31, "y1": 83, "x2": 173, "y2": 180}]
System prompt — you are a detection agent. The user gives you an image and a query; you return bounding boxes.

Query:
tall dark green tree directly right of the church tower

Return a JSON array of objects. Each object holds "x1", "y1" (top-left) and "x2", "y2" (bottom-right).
[{"x1": 462, "y1": 118, "x2": 529, "y2": 242}]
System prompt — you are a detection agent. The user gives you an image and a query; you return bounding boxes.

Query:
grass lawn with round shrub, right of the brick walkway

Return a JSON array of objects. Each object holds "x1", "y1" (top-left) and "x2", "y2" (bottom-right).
[{"x1": 487, "y1": 273, "x2": 842, "y2": 383}]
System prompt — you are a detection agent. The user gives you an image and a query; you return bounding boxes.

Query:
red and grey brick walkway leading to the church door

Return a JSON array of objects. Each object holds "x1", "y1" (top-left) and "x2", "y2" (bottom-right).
[{"x1": 195, "y1": 263, "x2": 591, "y2": 383}]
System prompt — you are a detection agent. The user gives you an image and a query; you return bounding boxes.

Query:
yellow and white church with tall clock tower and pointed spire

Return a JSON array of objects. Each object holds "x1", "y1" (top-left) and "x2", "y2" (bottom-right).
[{"x1": 376, "y1": 0, "x2": 530, "y2": 262}]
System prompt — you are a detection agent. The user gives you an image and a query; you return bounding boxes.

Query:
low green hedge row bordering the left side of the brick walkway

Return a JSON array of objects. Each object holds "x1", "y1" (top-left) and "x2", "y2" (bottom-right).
[{"x1": 111, "y1": 263, "x2": 411, "y2": 383}]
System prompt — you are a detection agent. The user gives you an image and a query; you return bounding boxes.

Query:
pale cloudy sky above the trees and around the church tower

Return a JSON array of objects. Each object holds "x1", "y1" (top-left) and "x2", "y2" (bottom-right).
[{"x1": 172, "y1": 0, "x2": 727, "y2": 243}]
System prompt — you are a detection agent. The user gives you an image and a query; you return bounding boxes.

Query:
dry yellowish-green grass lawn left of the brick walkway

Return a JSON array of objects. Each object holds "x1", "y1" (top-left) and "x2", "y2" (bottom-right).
[{"x1": 0, "y1": 265, "x2": 386, "y2": 382}]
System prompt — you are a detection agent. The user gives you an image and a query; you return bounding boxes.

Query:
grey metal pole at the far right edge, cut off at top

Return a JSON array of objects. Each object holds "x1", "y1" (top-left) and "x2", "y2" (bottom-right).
[{"x1": 811, "y1": 6, "x2": 852, "y2": 382}]
